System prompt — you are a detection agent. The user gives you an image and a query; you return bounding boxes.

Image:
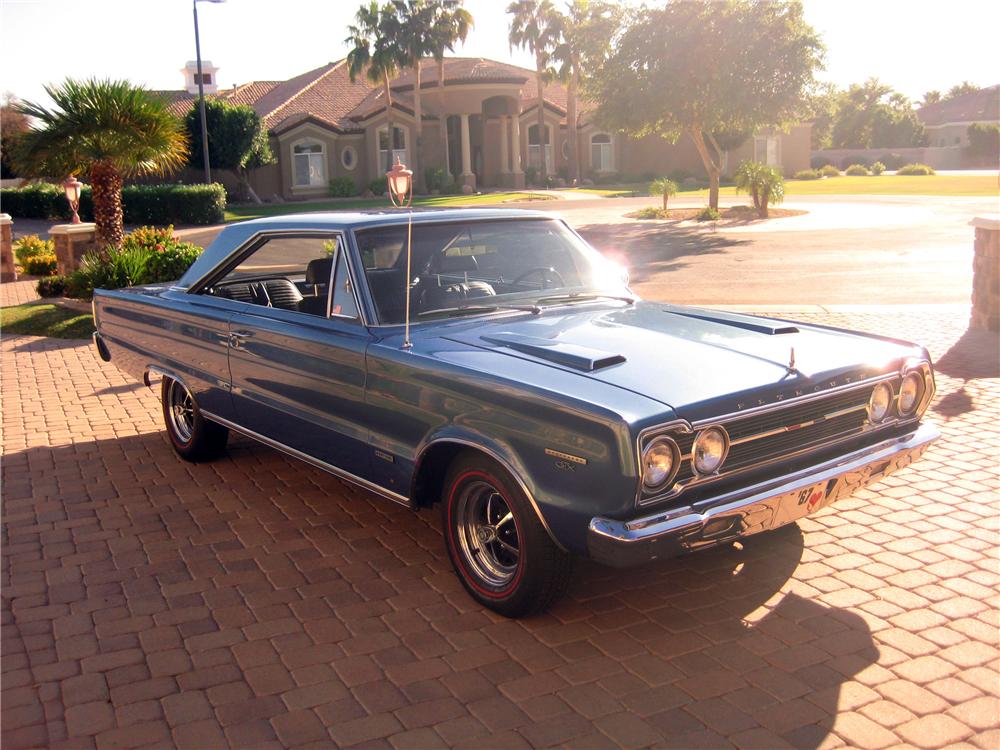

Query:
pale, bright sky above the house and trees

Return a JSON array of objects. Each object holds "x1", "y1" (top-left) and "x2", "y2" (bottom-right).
[{"x1": 0, "y1": 0, "x2": 1000, "y2": 108}]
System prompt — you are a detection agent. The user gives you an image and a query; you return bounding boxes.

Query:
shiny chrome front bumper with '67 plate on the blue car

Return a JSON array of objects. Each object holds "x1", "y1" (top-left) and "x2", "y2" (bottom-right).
[{"x1": 587, "y1": 424, "x2": 941, "y2": 568}]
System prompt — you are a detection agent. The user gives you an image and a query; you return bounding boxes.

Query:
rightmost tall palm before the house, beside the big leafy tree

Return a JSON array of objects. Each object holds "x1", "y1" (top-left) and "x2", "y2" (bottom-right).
[{"x1": 552, "y1": 0, "x2": 622, "y2": 181}]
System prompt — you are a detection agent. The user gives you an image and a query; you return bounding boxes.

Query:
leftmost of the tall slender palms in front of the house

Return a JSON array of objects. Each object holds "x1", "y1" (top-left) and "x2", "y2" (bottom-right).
[{"x1": 344, "y1": 0, "x2": 405, "y2": 171}]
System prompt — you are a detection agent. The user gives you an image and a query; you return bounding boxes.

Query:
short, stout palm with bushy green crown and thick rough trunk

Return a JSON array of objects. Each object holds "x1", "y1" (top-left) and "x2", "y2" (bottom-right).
[{"x1": 15, "y1": 78, "x2": 188, "y2": 249}]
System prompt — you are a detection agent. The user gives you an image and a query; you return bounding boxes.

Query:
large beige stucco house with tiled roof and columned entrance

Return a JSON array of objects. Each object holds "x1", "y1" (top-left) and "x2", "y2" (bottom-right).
[{"x1": 159, "y1": 57, "x2": 810, "y2": 200}]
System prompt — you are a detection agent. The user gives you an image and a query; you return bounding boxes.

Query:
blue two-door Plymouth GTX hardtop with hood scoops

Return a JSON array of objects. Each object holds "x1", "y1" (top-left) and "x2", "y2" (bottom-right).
[{"x1": 94, "y1": 209, "x2": 938, "y2": 616}]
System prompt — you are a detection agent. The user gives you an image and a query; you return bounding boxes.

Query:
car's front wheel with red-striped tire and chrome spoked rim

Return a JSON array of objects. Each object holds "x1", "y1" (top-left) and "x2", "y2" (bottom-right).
[{"x1": 441, "y1": 452, "x2": 573, "y2": 617}]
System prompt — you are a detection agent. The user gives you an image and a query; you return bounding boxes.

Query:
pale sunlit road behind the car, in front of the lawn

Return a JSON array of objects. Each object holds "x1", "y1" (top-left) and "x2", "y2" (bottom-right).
[{"x1": 166, "y1": 196, "x2": 1000, "y2": 305}]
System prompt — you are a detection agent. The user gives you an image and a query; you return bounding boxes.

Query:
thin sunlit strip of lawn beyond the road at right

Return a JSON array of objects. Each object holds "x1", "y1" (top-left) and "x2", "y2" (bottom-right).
[{"x1": 574, "y1": 174, "x2": 1000, "y2": 198}]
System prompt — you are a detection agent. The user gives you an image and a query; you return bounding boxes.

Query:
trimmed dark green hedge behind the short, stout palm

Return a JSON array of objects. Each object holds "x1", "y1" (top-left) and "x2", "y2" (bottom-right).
[{"x1": 0, "y1": 183, "x2": 226, "y2": 225}]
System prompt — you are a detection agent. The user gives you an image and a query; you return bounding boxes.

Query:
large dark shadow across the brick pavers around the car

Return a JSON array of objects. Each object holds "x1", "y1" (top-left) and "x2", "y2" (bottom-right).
[{"x1": 2, "y1": 426, "x2": 878, "y2": 748}]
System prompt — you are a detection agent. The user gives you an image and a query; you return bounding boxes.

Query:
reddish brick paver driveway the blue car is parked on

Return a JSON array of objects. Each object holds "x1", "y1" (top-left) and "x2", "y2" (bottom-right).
[{"x1": 2, "y1": 314, "x2": 1000, "y2": 750}]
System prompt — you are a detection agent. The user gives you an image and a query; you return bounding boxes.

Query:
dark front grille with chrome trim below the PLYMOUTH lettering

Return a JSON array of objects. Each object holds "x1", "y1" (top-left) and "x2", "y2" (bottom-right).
[{"x1": 641, "y1": 383, "x2": 895, "y2": 504}]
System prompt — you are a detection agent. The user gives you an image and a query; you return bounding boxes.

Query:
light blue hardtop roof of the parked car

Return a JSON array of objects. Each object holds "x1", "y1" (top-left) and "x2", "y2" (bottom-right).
[{"x1": 178, "y1": 208, "x2": 559, "y2": 287}]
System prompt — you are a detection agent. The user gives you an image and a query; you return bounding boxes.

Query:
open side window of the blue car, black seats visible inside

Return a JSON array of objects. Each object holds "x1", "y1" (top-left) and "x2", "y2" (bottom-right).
[{"x1": 203, "y1": 235, "x2": 338, "y2": 317}]
